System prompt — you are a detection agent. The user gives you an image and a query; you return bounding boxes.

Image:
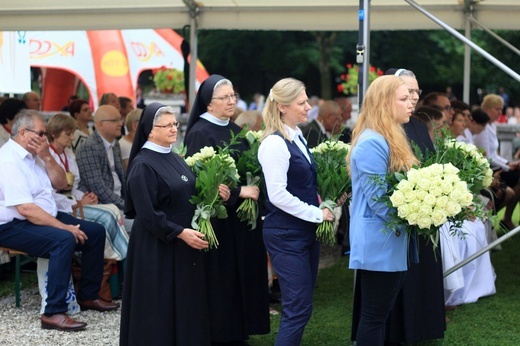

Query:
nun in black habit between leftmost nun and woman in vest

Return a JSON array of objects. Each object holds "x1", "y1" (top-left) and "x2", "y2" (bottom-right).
[{"x1": 184, "y1": 75, "x2": 270, "y2": 343}]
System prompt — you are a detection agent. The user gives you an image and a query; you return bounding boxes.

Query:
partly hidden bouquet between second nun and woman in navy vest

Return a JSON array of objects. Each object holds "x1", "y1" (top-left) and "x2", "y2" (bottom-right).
[{"x1": 237, "y1": 131, "x2": 262, "y2": 229}]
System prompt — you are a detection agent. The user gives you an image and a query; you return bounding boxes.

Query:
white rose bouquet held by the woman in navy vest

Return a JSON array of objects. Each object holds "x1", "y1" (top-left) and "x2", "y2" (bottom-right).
[{"x1": 311, "y1": 140, "x2": 352, "y2": 245}]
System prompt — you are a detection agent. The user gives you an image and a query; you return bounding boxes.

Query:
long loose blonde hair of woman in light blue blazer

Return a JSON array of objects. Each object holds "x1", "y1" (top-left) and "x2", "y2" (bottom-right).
[{"x1": 347, "y1": 76, "x2": 419, "y2": 172}]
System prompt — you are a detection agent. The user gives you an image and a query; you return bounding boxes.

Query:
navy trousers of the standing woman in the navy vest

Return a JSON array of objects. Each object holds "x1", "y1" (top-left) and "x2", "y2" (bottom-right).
[{"x1": 263, "y1": 227, "x2": 320, "y2": 346}]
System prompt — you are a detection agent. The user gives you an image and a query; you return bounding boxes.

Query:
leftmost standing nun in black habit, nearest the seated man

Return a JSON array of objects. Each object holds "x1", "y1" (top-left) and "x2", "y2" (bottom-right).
[{"x1": 120, "y1": 103, "x2": 210, "y2": 346}]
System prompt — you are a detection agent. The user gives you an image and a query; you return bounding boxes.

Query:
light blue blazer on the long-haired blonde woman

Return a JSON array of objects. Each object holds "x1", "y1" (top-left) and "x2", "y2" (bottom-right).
[{"x1": 349, "y1": 129, "x2": 409, "y2": 272}]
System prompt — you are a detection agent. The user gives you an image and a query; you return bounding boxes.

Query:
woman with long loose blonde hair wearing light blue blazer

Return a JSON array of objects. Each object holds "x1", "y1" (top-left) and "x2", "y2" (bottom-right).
[{"x1": 347, "y1": 76, "x2": 418, "y2": 346}]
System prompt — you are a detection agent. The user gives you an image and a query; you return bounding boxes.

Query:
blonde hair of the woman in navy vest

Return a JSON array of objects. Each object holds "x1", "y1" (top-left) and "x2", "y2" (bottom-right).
[{"x1": 262, "y1": 78, "x2": 305, "y2": 141}]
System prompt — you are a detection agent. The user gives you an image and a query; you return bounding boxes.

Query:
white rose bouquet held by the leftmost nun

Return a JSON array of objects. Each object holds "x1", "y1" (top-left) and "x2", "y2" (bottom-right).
[{"x1": 186, "y1": 147, "x2": 239, "y2": 249}]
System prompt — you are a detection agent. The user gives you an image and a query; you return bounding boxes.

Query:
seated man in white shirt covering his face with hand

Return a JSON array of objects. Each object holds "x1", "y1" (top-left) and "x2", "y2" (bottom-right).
[{"x1": 0, "y1": 110, "x2": 119, "y2": 331}]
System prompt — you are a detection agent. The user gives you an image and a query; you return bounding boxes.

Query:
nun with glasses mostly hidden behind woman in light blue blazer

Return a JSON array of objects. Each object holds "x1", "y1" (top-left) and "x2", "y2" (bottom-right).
[{"x1": 382, "y1": 68, "x2": 446, "y2": 345}]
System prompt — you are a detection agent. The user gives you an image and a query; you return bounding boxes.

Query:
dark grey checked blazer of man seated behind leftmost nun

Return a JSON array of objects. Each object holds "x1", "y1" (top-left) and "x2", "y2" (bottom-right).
[{"x1": 76, "y1": 132, "x2": 125, "y2": 209}]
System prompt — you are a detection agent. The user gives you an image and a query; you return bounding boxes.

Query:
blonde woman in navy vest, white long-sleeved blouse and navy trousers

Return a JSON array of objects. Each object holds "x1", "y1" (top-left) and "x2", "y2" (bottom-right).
[{"x1": 258, "y1": 78, "x2": 334, "y2": 346}]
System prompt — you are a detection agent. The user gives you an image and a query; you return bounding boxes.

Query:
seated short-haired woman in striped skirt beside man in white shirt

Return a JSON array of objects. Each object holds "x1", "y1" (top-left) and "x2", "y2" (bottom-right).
[{"x1": 47, "y1": 113, "x2": 128, "y2": 261}]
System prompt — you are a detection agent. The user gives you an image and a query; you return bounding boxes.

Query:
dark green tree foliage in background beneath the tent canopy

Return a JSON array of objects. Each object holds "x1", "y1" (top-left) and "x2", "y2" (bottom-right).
[{"x1": 199, "y1": 30, "x2": 520, "y2": 105}]
